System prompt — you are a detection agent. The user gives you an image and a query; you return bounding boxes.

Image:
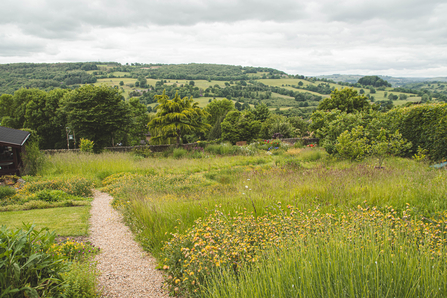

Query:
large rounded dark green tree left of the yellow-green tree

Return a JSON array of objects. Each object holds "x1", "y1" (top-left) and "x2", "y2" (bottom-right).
[{"x1": 63, "y1": 85, "x2": 130, "y2": 152}]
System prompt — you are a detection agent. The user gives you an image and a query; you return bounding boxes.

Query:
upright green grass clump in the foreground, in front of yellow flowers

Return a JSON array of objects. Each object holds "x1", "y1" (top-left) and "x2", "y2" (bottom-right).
[{"x1": 203, "y1": 227, "x2": 447, "y2": 298}]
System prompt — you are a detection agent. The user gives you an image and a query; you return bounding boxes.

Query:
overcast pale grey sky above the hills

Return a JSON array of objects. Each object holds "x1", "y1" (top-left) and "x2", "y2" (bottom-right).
[{"x1": 0, "y1": 0, "x2": 447, "y2": 77}]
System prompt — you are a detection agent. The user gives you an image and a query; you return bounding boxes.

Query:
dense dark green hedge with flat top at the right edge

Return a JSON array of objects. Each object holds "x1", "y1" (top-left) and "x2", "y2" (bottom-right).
[{"x1": 386, "y1": 104, "x2": 447, "y2": 161}]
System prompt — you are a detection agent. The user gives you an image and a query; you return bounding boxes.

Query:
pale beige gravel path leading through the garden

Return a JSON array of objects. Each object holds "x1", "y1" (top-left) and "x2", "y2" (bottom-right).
[{"x1": 90, "y1": 191, "x2": 168, "y2": 298}]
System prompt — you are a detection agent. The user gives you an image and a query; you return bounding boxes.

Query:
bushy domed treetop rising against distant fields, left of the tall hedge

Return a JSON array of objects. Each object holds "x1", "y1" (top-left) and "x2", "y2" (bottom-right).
[{"x1": 317, "y1": 88, "x2": 371, "y2": 113}]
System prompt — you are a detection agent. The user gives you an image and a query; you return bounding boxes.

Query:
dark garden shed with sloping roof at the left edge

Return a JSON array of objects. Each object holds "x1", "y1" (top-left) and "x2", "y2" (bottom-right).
[{"x1": 0, "y1": 126, "x2": 31, "y2": 176}]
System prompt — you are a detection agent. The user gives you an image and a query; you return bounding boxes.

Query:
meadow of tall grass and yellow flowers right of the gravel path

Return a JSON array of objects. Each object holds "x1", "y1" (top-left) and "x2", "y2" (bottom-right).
[{"x1": 33, "y1": 147, "x2": 447, "y2": 297}]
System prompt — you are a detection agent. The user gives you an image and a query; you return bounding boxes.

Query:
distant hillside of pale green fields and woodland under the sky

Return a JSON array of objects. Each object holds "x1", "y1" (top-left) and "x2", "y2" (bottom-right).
[{"x1": 0, "y1": 62, "x2": 447, "y2": 118}]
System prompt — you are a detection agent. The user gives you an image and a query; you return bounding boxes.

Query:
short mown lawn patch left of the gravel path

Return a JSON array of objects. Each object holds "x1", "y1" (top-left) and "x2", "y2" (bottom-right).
[{"x1": 0, "y1": 206, "x2": 90, "y2": 236}]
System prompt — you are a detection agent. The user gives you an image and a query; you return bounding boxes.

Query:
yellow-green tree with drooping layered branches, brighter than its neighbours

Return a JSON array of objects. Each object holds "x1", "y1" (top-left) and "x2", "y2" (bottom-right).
[{"x1": 148, "y1": 91, "x2": 211, "y2": 146}]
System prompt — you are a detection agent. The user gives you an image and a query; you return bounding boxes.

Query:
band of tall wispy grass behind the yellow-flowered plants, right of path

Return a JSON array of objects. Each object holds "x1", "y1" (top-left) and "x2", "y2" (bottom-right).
[{"x1": 99, "y1": 155, "x2": 447, "y2": 255}]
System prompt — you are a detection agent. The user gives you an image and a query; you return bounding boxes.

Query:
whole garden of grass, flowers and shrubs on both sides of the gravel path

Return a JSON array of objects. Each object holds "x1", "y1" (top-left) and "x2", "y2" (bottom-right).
[{"x1": 0, "y1": 100, "x2": 447, "y2": 298}]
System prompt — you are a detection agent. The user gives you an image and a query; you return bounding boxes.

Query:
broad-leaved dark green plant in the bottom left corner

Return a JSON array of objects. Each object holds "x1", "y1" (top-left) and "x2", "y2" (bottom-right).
[{"x1": 0, "y1": 226, "x2": 69, "y2": 298}]
